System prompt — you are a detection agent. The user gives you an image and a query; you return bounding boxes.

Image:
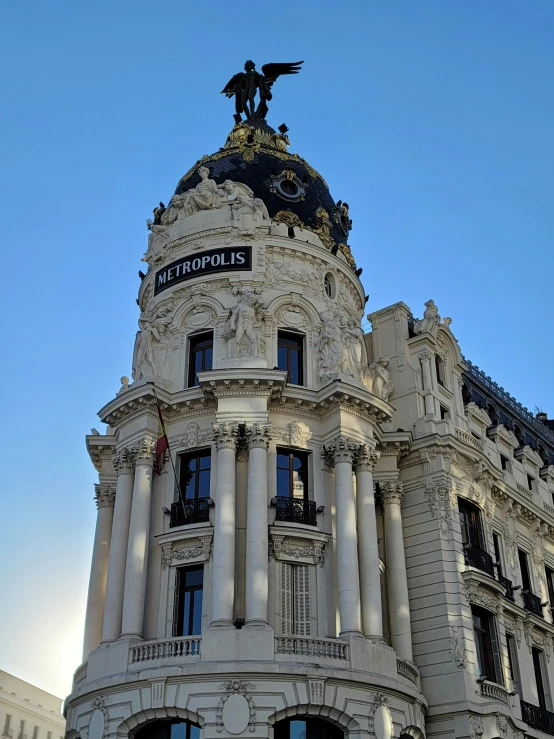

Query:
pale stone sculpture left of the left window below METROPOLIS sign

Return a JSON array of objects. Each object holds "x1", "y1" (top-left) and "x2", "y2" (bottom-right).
[{"x1": 133, "y1": 304, "x2": 173, "y2": 381}]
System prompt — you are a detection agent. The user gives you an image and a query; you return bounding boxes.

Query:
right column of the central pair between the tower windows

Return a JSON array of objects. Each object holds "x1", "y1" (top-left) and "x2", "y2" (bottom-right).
[{"x1": 246, "y1": 423, "x2": 271, "y2": 625}]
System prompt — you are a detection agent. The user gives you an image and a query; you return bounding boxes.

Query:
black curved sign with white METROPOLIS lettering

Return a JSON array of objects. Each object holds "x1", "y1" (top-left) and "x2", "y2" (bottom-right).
[{"x1": 154, "y1": 246, "x2": 252, "y2": 295}]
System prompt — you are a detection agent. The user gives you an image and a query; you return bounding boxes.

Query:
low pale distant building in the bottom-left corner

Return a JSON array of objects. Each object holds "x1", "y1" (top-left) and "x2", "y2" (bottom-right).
[{"x1": 0, "y1": 670, "x2": 65, "y2": 739}]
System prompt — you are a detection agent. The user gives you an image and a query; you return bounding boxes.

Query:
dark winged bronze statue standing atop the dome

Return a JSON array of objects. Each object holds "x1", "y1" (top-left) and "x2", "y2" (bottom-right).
[{"x1": 221, "y1": 59, "x2": 304, "y2": 123}]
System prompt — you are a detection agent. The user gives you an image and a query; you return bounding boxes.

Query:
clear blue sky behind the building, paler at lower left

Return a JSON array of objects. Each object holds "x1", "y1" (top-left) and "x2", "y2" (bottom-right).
[{"x1": 0, "y1": 0, "x2": 554, "y2": 695}]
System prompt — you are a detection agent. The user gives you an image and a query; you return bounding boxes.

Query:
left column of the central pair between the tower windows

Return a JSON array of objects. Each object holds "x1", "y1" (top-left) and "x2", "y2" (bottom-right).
[{"x1": 211, "y1": 423, "x2": 237, "y2": 626}]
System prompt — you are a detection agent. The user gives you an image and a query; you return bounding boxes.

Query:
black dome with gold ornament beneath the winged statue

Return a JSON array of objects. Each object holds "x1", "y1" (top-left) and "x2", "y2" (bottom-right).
[{"x1": 175, "y1": 137, "x2": 349, "y2": 244}]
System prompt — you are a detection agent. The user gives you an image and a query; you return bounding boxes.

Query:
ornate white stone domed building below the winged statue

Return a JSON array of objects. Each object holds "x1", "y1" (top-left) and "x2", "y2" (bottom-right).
[{"x1": 66, "y1": 107, "x2": 554, "y2": 739}]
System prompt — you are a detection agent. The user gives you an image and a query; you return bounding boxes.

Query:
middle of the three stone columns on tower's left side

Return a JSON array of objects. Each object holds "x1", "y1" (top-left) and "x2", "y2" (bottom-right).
[{"x1": 102, "y1": 448, "x2": 135, "y2": 641}]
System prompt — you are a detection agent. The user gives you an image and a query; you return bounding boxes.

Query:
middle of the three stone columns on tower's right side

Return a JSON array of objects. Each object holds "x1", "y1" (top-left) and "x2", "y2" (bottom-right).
[{"x1": 356, "y1": 444, "x2": 383, "y2": 639}]
